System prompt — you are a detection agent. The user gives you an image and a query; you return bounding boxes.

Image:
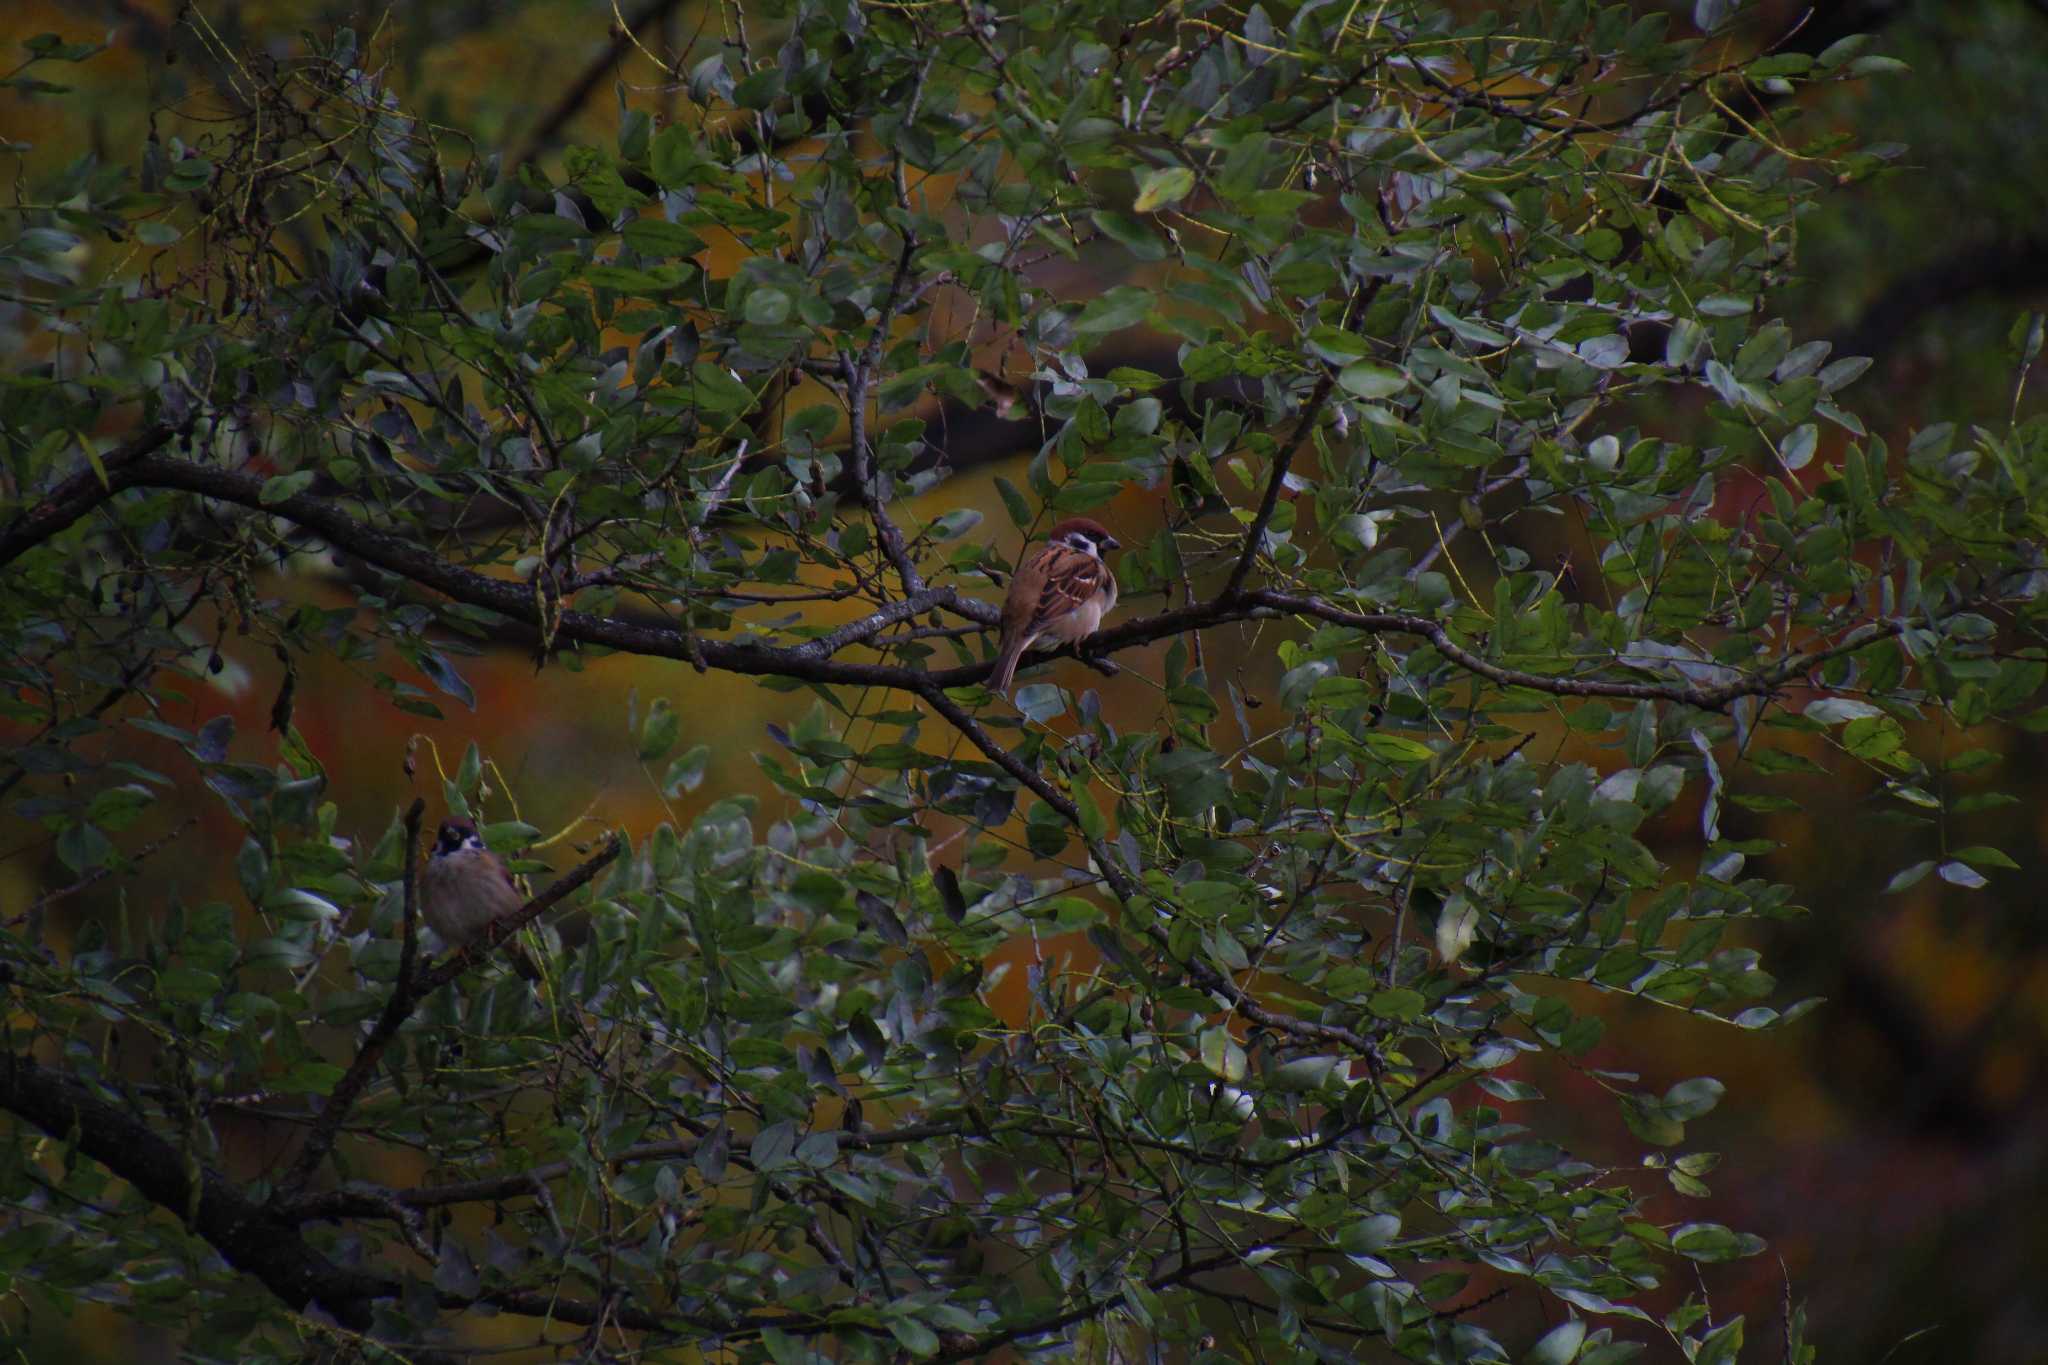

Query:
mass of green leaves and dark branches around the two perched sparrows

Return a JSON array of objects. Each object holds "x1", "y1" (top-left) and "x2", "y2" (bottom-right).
[{"x1": 0, "y1": 0, "x2": 2048, "y2": 1363}]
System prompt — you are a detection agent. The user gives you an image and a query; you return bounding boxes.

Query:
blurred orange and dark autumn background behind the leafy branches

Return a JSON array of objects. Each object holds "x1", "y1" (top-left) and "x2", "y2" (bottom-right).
[{"x1": 0, "y1": 0, "x2": 2048, "y2": 1363}]
